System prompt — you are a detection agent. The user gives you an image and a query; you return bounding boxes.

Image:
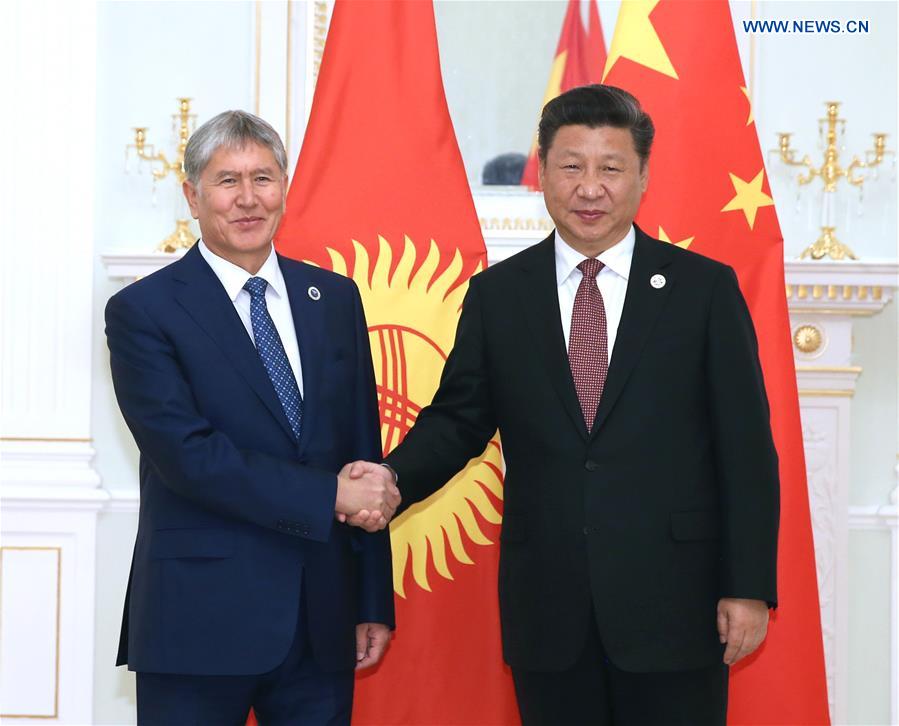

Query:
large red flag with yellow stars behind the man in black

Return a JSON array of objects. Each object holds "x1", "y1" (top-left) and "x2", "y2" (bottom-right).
[{"x1": 604, "y1": 0, "x2": 829, "y2": 726}]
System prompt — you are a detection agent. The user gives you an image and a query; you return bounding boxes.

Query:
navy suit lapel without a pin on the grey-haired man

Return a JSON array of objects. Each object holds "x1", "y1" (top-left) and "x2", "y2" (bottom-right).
[{"x1": 174, "y1": 245, "x2": 305, "y2": 438}]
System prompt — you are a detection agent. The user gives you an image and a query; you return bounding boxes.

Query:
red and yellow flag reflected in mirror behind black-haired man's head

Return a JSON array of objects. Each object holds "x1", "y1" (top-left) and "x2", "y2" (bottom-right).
[{"x1": 521, "y1": 0, "x2": 606, "y2": 189}]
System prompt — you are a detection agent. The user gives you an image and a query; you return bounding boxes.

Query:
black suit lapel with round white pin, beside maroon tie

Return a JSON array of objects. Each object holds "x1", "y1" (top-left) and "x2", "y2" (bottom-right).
[{"x1": 590, "y1": 227, "x2": 676, "y2": 438}]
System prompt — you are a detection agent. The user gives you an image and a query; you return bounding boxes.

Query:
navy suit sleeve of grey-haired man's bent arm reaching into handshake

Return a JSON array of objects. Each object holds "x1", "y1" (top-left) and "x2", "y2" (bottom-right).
[{"x1": 106, "y1": 293, "x2": 337, "y2": 542}]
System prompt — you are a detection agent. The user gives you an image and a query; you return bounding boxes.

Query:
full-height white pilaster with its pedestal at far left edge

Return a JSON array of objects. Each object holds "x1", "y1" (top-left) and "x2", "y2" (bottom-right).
[{"x1": 0, "y1": 2, "x2": 107, "y2": 724}]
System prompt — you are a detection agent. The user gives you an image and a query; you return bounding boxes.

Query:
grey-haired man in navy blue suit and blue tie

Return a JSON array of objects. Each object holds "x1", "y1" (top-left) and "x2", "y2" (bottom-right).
[{"x1": 106, "y1": 111, "x2": 399, "y2": 726}]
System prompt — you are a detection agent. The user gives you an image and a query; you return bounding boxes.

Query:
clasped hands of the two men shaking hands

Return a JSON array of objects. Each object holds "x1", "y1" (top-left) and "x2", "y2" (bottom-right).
[{"x1": 334, "y1": 461, "x2": 401, "y2": 532}]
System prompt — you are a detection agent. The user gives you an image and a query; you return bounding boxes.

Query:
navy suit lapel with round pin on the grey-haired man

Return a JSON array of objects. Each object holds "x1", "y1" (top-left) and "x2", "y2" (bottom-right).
[{"x1": 278, "y1": 255, "x2": 329, "y2": 450}]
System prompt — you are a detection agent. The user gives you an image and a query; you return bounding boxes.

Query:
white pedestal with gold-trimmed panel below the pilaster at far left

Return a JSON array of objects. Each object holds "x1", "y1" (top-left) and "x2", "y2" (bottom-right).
[{"x1": 0, "y1": 510, "x2": 105, "y2": 724}]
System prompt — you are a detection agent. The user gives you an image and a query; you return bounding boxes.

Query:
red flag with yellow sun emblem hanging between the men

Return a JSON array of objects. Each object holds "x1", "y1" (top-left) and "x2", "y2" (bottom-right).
[{"x1": 276, "y1": 0, "x2": 518, "y2": 724}]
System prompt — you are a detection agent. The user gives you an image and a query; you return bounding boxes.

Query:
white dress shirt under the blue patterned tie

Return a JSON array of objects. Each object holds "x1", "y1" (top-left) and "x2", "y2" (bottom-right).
[{"x1": 198, "y1": 239, "x2": 306, "y2": 396}]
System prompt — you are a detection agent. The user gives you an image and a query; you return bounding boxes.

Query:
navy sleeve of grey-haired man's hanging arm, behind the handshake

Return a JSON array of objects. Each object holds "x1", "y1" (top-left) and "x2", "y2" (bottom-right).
[{"x1": 348, "y1": 285, "x2": 395, "y2": 628}]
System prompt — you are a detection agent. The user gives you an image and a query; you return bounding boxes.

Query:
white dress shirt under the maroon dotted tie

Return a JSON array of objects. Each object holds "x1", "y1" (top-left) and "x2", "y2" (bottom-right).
[{"x1": 555, "y1": 225, "x2": 637, "y2": 361}]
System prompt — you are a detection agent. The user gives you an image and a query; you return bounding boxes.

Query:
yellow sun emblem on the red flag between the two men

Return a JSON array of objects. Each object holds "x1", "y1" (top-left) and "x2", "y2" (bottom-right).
[{"x1": 316, "y1": 236, "x2": 503, "y2": 597}]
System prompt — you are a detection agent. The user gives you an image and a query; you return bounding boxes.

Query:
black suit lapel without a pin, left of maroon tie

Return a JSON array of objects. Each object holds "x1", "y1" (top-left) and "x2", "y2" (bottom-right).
[{"x1": 518, "y1": 234, "x2": 587, "y2": 439}]
